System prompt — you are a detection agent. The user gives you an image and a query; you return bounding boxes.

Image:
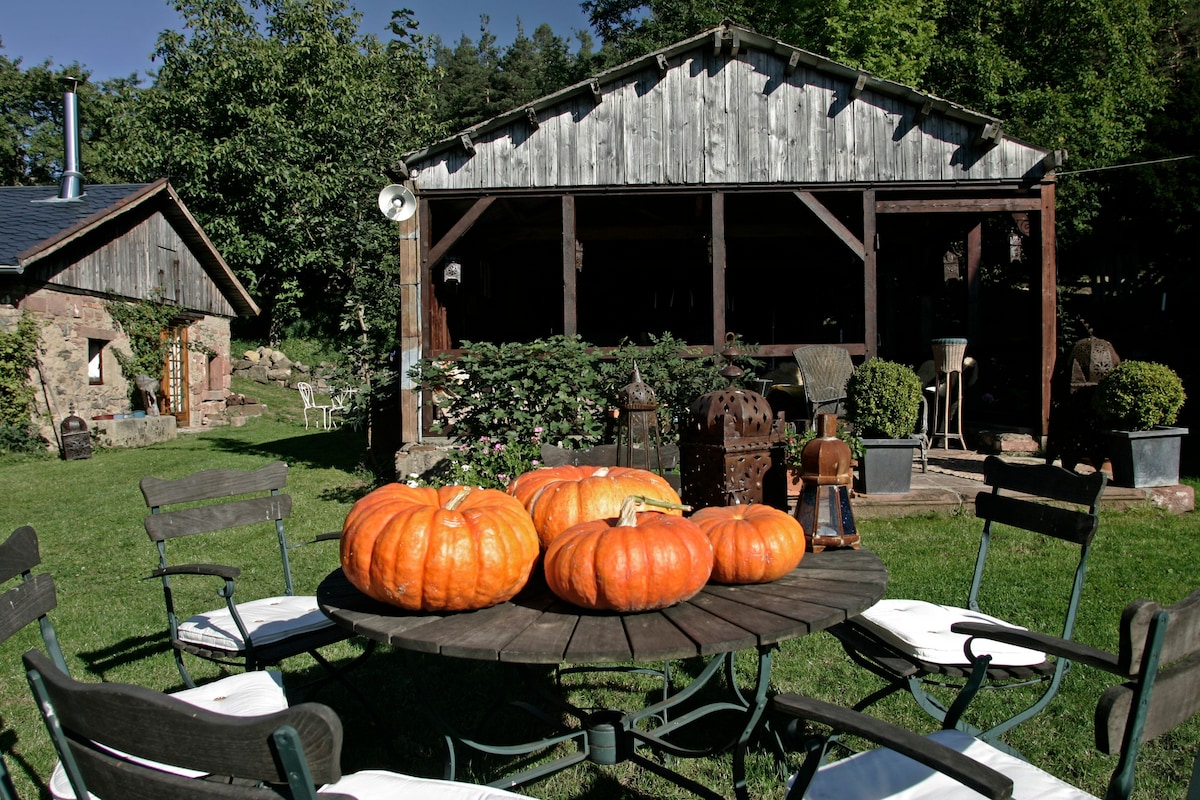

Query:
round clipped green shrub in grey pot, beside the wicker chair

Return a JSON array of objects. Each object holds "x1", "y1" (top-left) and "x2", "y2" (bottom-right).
[{"x1": 846, "y1": 359, "x2": 920, "y2": 439}]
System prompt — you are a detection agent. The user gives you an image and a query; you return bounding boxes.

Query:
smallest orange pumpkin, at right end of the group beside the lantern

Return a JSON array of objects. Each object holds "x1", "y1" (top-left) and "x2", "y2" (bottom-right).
[{"x1": 691, "y1": 504, "x2": 804, "y2": 583}]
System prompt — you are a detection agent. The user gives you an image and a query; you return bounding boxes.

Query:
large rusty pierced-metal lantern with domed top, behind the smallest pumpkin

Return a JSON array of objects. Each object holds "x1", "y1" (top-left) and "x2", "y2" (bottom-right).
[{"x1": 679, "y1": 335, "x2": 786, "y2": 509}]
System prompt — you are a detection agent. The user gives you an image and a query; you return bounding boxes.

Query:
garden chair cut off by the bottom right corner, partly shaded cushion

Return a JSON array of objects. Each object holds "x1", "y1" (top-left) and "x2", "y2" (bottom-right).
[{"x1": 773, "y1": 582, "x2": 1200, "y2": 800}]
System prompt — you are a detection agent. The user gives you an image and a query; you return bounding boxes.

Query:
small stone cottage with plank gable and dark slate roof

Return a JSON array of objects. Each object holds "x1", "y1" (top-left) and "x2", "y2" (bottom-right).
[{"x1": 0, "y1": 179, "x2": 258, "y2": 441}]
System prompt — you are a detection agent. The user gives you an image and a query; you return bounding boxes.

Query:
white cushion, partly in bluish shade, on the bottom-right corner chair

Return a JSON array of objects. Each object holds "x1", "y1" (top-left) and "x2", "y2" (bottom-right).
[{"x1": 804, "y1": 730, "x2": 1094, "y2": 800}]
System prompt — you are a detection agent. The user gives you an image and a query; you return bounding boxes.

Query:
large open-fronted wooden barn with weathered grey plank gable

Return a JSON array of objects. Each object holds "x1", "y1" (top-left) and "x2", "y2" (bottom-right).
[{"x1": 391, "y1": 24, "x2": 1062, "y2": 441}]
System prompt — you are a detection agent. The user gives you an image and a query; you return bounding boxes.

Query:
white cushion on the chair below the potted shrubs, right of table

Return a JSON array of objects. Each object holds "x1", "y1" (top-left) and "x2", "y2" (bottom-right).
[{"x1": 854, "y1": 600, "x2": 1046, "y2": 667}]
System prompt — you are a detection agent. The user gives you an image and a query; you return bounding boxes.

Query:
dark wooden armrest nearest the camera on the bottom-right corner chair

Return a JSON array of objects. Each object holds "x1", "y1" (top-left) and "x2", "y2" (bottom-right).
[{"x1": 772, "y1": 694, "x2": 1013, "y2": 800}]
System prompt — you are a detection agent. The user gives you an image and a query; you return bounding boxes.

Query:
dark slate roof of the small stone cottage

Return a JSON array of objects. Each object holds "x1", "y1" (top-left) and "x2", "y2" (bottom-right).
[{"x1": 0, "y1": 179, "x2": 259, "y2": 315}]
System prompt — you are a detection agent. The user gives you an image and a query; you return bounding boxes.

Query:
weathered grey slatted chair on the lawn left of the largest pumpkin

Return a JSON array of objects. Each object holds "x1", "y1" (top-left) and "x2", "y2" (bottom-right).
[{"x1": 140, "y1": 462, "x2": 373, "y2": 686}]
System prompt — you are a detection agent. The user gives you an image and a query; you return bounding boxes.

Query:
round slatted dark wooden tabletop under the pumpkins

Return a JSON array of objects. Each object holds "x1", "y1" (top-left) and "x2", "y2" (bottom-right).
[{"x1": 317, "y1": 549, "x2": 887, "y2": 664}]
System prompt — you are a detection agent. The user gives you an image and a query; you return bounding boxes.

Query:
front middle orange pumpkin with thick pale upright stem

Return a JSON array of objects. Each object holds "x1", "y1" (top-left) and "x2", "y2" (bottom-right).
[{"x1": 542, "y1": 498, "x2": 713, "y2": 612}]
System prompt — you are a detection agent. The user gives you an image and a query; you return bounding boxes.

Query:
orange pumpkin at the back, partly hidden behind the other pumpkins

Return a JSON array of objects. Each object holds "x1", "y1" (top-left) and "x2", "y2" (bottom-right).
[{"x1": 508, "y1": 464, "x2": 682, "y2": 547}]
